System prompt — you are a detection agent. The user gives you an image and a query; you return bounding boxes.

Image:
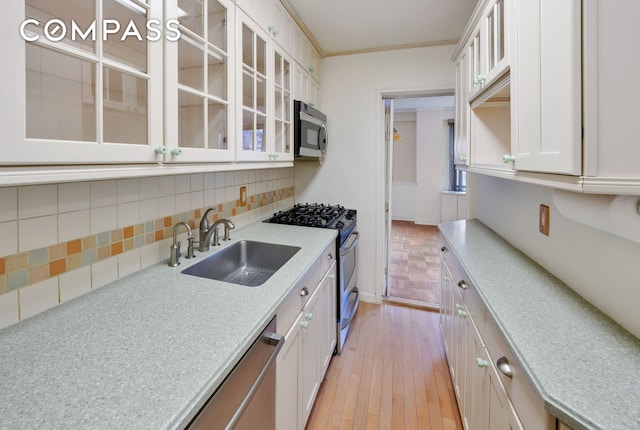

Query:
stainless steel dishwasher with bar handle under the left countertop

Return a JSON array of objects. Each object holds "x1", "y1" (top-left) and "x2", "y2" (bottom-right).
[{"x1": 188, "y1": 317, "x2": 284, "y2": 430}]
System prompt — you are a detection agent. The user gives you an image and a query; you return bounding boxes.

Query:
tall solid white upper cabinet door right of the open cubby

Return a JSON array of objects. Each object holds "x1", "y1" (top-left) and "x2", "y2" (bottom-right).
[{"x1": 511, "y1": 0, "x2": 582, "y2": 176}]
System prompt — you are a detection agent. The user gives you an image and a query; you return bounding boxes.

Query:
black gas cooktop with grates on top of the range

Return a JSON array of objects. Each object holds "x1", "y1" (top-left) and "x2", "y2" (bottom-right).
[{"x1": 265, "y1": 203, "x2": 357, "y2": 246}]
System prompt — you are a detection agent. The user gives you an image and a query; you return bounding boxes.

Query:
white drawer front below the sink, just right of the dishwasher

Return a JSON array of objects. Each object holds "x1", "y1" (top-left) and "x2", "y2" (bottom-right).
[{"x1": 277, "y1": 254, "x2": 324, "y2": 333}]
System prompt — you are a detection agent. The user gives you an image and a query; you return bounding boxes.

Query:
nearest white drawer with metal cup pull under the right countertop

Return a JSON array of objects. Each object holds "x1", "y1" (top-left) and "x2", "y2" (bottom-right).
[{"x1": 480, "y1": 317, "x2": 555, "y2": 429}]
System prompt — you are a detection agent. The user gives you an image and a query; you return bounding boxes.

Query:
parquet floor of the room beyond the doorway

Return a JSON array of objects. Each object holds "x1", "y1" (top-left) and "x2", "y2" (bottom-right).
[{"x1": 388, "y1": 221, "x2": 440, "y2": 309}]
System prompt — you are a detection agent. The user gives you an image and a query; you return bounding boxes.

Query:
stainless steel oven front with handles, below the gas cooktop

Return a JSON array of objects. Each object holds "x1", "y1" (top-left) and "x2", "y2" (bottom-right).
[{"x1": 337, "y1": 231, "x2": 360, "y2": 354}]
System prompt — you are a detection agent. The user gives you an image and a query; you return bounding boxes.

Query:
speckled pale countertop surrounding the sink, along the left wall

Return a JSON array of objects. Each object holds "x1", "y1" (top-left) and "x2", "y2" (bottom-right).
[{"x1": 0, "y1": 222, "x2": 336, "y2": 430}]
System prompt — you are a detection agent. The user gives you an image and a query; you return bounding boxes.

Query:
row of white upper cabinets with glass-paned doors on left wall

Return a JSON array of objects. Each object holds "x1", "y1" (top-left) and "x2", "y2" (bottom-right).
[{"x1": 0, "y1": 0, "x2": 304, "y2": 170}]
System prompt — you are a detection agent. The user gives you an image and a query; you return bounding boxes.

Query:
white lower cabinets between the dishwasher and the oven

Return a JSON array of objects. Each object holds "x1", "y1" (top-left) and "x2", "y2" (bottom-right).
[{"x1": 276, "y1": 243, "x2": 336, "y2": 430}]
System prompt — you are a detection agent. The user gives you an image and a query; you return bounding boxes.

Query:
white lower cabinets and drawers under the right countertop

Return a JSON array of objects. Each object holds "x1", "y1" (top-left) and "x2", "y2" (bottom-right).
[{"x1": 440, "y1": 245, "x2": 555, "y2": 430}]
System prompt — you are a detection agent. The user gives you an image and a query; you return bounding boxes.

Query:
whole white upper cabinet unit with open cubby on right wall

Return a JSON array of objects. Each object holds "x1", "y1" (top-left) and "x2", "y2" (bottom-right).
[{"x1": 453, "y1": 0, "x2": 640, "y2": 195}]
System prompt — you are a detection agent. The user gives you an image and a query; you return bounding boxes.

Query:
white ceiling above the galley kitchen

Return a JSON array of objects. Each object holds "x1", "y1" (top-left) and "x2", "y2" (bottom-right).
[{"x1": 282, "y1": 0, "x2": 477, "y2": 56}]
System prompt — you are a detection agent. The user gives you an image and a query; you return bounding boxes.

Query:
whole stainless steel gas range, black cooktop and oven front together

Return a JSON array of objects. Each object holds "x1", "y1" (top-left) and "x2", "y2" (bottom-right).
[{"x1": 265, "y1": 203, "x2": 360, "y2": 354}]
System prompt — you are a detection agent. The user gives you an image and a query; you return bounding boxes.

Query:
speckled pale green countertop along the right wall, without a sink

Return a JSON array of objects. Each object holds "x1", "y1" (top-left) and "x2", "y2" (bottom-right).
[{"x1": 440, "y1": 220, "x2": 640, "y2": 430}]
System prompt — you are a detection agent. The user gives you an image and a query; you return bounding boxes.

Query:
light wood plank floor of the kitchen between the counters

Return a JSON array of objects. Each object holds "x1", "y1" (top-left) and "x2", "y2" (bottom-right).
[{"x1": 306, "y1": 302, "x2": 462, "y2": 430}]
